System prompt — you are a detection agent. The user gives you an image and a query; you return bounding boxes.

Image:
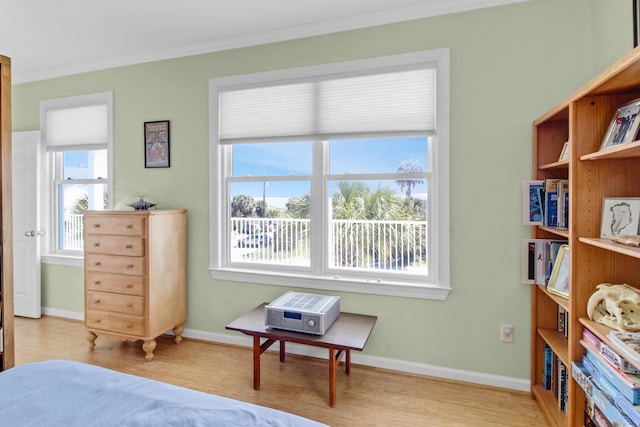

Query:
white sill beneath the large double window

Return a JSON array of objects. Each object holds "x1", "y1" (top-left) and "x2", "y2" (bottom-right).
[{"x1": 209, "y1": 268, "x2": 451, "y2": 300}]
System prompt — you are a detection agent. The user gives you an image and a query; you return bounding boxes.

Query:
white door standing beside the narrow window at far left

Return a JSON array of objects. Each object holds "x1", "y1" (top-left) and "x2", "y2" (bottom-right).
[{"x1": 11, "y1": 131, "x2": 42, "y2": 318}]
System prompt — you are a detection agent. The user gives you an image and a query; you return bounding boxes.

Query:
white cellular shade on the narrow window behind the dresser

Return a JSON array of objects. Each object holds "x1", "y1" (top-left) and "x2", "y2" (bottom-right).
[{"x1": 41, "y1": 93, "x2": 112, "y2": 151}]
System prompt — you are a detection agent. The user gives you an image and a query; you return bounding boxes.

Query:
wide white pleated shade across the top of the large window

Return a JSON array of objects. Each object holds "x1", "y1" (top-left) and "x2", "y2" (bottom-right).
[{"x1": 218, "y1": 64, "x2": 436, "y2": 144}]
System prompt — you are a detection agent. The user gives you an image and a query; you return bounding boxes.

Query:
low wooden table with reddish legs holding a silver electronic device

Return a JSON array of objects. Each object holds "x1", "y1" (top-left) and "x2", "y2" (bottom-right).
[{"x1": 226, "y1": 302, "x2": 378, "y2": 407}]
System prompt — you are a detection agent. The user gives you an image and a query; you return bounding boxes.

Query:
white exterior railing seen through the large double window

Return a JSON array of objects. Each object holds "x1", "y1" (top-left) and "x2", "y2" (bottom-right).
[{"x1": 230, "y1": 218, "x2": 427, "y2": 272}]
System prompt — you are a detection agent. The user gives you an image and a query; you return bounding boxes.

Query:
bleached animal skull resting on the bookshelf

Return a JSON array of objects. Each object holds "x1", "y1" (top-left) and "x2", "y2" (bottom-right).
[{"x1": 587, "y1": 283, "x2": 640, "y2": 332}]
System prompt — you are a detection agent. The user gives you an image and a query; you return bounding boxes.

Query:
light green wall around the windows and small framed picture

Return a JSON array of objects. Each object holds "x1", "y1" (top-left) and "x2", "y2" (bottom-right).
[{"x1": 13, "y1": 0, "x2": 631, "y2": 379}]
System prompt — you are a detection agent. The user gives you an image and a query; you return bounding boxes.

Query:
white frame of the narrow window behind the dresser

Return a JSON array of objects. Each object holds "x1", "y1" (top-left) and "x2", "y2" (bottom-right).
[{"x1": 40, "y1": 92, "x2": 114, "y2": 267}]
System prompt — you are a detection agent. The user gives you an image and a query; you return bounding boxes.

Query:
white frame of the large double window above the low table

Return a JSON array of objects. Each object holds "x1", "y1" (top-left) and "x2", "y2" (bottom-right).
[{"x1": 209, "y1": 48, "x2": 451, "y2": 300}]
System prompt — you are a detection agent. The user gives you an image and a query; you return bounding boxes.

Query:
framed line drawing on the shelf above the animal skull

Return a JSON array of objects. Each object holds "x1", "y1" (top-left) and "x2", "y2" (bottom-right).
[{"x1": 600, "y1": 197, "x2": 640, "y2": 238}]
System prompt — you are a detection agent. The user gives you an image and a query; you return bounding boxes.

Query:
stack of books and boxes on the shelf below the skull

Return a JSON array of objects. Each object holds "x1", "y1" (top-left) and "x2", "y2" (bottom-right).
[{"x1": 572, "y1": 328, "x2": 640, "y2": 427}]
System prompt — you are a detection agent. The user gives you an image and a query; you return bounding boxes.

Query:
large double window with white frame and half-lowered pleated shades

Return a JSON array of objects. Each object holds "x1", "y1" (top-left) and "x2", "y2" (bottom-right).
[{"x1": 210, "y1": 50, "x2": 449, "y2": 299}]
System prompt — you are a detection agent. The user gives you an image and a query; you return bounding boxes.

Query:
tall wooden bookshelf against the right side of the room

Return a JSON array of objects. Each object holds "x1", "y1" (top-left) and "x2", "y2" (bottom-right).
[{"x1": 531, "y1": 48, "x2": 640, "y2": 426}]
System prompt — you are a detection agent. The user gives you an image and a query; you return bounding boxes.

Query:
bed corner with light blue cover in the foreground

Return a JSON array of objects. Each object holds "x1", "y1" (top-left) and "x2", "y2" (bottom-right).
[{"x1": 0, "y1": 360, "x2": 326, "y2": 427}]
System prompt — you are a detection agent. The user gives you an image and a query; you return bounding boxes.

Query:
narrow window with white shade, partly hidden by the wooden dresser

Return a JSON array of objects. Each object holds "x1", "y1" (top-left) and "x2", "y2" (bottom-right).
[{"x1": 40, "y1": 92, "x2": 113, "y2": 258}]
